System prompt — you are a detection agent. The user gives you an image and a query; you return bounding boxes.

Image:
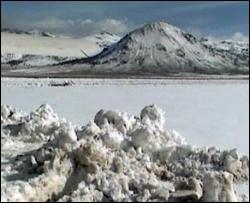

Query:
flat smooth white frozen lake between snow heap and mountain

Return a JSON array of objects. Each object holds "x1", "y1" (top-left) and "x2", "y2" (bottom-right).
[{"x1": 1, "y1": 79, "x2": 249, "y2": 154}]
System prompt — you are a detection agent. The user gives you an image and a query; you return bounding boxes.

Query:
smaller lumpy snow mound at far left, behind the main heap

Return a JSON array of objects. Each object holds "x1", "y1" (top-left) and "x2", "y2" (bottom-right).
[{"x1": 1, "y1": 104, "x2": 72, "y2": 141}]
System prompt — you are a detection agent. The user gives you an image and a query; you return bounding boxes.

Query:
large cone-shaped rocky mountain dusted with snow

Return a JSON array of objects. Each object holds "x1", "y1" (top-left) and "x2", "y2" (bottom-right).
[{"x1": 64, "y1": 22, "x2": 249, "y2": 74}]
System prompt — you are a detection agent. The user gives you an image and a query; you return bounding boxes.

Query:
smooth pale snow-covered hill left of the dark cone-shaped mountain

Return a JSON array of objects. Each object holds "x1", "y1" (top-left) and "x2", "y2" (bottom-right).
[{"x1": 1, "y1": 29, "x2": 120, "y2": 66}]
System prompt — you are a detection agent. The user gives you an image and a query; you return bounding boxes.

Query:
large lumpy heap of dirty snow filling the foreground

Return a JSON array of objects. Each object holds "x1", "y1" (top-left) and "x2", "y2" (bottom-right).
[{"x1": 1, "y1": 105, "x2": 249, "y2": 202}]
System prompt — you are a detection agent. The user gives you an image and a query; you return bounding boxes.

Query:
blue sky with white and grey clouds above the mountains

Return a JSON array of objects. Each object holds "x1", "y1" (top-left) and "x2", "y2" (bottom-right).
[{"x1": 1, "y1": 1, "x2": 249, "y2": 40}]
